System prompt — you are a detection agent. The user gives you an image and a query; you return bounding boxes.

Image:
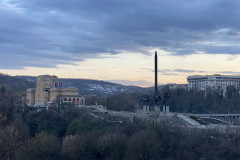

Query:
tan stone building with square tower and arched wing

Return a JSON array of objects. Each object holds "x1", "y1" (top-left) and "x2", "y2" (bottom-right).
[{"x1": 27, "y1": 75, "x2": 85, "y2": 106}]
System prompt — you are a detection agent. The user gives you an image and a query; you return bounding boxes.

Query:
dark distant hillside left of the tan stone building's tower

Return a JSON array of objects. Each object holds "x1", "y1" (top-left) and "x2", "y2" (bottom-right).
[{"x1": 0, "y1": 73, "x2": 35, "y2": 92}]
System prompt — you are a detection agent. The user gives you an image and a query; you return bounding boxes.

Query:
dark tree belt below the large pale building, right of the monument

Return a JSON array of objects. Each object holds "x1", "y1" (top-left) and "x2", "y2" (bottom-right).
[{"x1": 161, "y1": 86, "x2": 240, "y2": 113}]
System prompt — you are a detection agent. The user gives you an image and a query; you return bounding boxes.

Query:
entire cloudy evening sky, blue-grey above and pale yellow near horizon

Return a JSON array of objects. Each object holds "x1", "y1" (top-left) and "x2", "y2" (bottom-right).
[{"x1": 0, "y1": 0, "x2": 240, "y2": 87}]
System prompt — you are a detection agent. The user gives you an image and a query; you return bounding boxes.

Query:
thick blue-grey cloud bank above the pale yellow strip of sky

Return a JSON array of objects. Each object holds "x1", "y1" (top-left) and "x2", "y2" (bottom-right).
[{"x1": 0, "y1": 0, "x2": 240, "y2": 69}]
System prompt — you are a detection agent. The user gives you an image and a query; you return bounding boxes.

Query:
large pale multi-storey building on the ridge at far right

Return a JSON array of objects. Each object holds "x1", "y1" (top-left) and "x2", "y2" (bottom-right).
[{"x1": 187, "y1": 74, "x2": 240, "y2": 91}]
